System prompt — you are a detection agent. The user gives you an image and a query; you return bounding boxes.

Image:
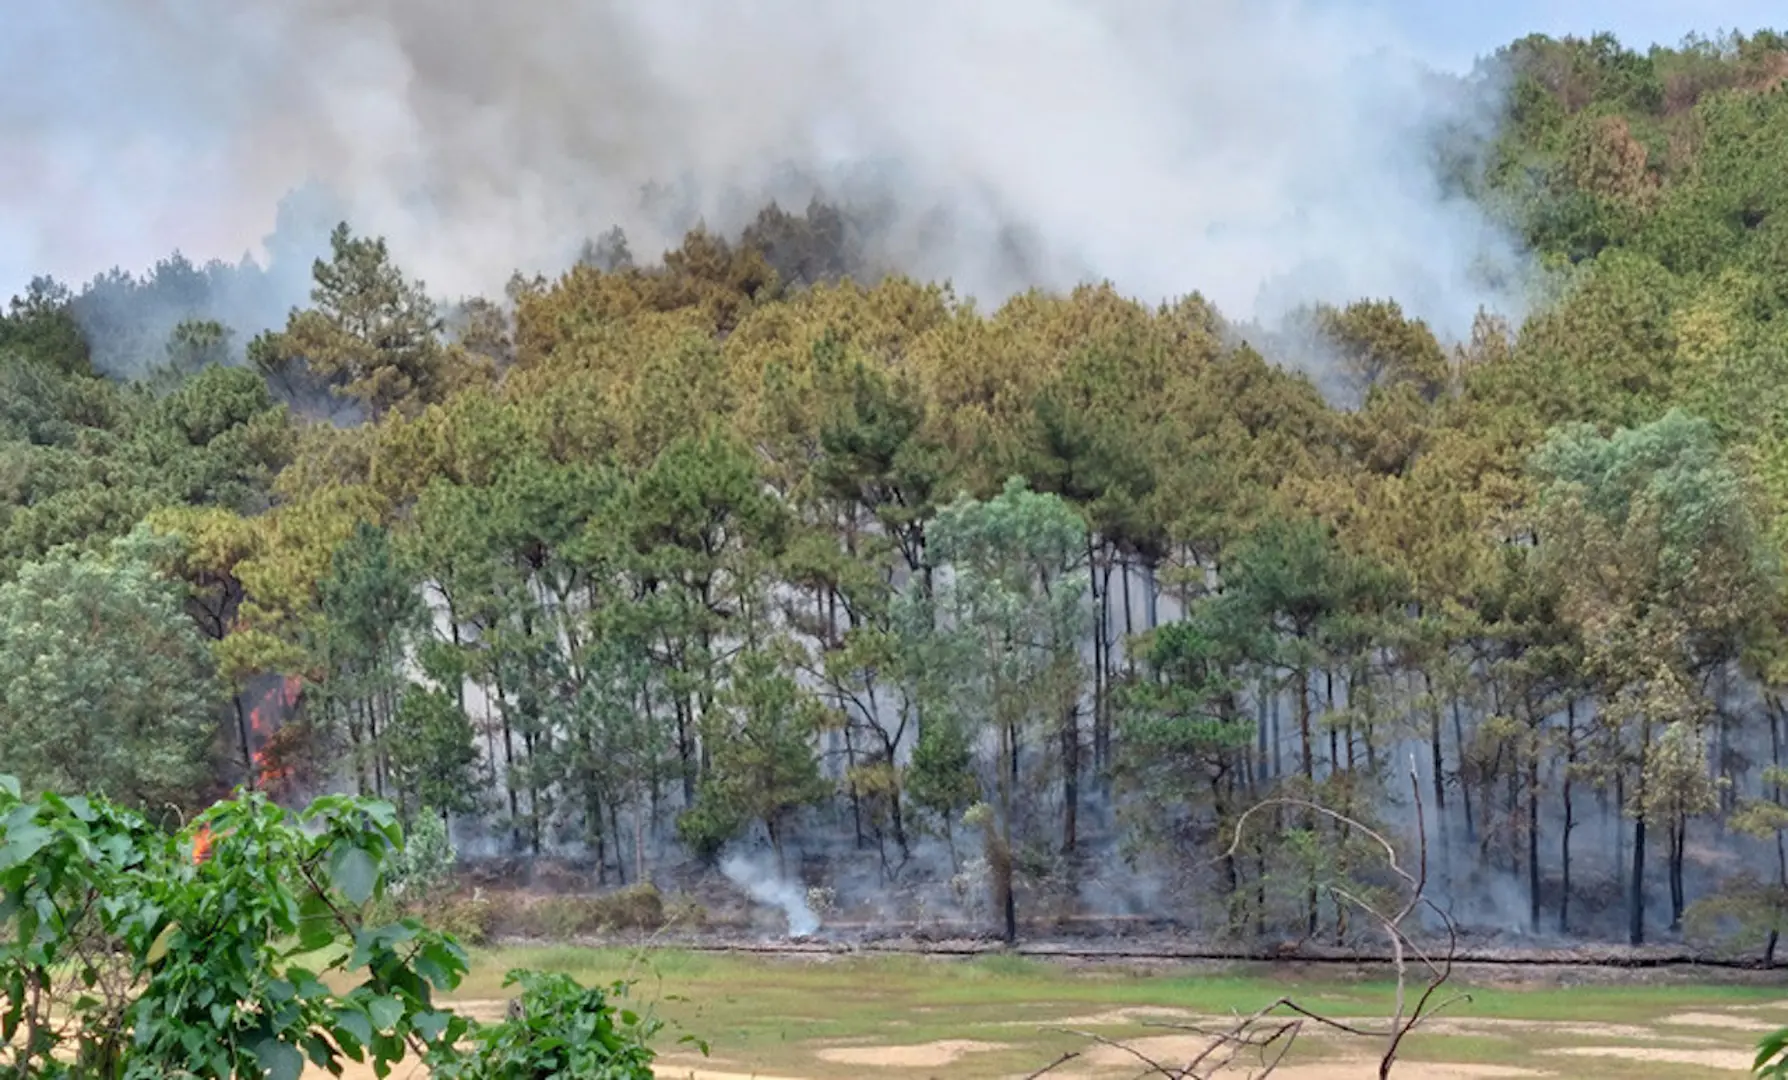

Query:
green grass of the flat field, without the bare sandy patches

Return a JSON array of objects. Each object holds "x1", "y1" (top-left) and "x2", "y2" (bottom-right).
[{"x1": 429, "y1": 946, "x2": 1788, "y2": 1080}]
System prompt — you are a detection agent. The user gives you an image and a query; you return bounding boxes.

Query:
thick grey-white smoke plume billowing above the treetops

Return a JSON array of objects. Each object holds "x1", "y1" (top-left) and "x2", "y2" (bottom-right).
[{"x1": 0, "y1": 0, "x2": 1520, "y2": 331}]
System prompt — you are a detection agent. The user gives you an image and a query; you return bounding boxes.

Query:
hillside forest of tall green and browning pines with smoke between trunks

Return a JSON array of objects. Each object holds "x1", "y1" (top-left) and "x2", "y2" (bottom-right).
[{"x1": 10, "y1": 34, "x2": 1788, "y2": 957}]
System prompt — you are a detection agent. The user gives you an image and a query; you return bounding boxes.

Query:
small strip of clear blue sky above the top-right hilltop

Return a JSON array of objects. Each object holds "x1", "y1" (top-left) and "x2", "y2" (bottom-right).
[{"x1": 1366, "y1": 0, "x2": 1788, "y2": 66}]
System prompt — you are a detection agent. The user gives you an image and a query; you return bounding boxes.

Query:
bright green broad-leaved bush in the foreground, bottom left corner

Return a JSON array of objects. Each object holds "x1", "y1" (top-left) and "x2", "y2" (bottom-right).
[{"x1": 0, "y1": 776, "x2": 672, "y2": 1080}]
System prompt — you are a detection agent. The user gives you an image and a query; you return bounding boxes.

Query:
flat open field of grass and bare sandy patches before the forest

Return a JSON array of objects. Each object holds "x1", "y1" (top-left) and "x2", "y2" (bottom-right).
[{"x1": 321, "y1": 946, "x2": 1788, "y2": 1080}]
